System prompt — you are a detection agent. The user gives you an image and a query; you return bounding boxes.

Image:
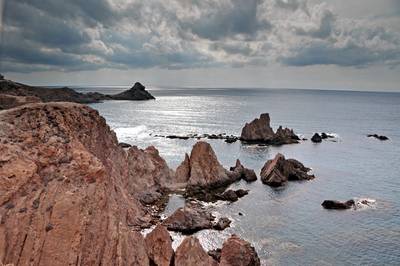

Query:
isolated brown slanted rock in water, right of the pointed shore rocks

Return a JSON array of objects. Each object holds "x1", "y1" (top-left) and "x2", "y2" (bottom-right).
[{"x1": 260, "y1": 153, "x2": 315, "y2": 187}]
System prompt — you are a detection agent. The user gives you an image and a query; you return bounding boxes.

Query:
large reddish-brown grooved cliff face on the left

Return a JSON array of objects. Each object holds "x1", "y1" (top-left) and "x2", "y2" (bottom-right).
[{"x1": 0, "y1": 103, "x2": 171, "y2": 265}]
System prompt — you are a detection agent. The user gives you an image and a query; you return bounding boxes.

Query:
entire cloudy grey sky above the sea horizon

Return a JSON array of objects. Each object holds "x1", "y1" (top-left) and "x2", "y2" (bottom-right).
[{"x1": 0, "y1": 0, "x2": 400, "y2": 91}]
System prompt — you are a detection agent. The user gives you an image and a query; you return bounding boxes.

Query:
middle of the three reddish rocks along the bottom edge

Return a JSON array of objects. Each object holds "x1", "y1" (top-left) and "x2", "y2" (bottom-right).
[{"x1": 175, "y1": 236, "x2": 218, "y2": 266}]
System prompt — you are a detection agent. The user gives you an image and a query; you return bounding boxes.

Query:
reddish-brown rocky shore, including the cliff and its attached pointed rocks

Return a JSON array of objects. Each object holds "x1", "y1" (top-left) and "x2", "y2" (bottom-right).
[{"x1": 0, "y1": 102, "x2": 259, "y2": 265}]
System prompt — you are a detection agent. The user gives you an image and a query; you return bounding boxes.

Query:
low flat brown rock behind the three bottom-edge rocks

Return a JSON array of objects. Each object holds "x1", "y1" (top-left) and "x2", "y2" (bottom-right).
[{"x1": 162, "y1": 206, "x2": 215, "y2": 234}]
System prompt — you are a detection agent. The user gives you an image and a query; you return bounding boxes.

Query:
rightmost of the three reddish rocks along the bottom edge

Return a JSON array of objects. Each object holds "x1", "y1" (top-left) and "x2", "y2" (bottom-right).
[{"x1": 219, "y1": 235, "x2": 260, "y2": 266}]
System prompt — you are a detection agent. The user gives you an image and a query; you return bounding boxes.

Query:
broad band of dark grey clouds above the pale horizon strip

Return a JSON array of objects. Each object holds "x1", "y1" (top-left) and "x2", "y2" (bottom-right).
[{"x1": 1, "y1": 0, "x2": 400, "y2": 72}]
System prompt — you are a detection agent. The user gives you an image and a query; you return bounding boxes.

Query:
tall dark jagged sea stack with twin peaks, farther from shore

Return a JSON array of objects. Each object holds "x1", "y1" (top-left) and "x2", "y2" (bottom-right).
[{"x1": 240, "y1": 113, "x2": 300, "y2": 145}]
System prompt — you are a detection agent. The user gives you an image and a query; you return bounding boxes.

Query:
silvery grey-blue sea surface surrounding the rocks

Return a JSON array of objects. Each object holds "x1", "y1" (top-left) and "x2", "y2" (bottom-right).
[{"x1": 79, "y1": 87, "x2": 400, "y2": 265}]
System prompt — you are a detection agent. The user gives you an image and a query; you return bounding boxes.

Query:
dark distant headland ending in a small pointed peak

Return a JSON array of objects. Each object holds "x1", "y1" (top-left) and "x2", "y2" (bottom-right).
[{"x1": 0, "y1": 79, "x2": 155, "y2": 103}]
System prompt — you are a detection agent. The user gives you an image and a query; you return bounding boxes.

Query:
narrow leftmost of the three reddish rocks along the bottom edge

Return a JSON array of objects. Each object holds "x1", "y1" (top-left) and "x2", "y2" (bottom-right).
[{"x1": 145, "y1": 225, "x2": 174, "y2": 266}]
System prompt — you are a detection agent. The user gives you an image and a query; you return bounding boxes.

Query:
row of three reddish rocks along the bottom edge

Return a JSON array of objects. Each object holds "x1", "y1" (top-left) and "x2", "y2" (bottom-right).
[{"x1": 144, "y1": 225, "x2": 260, "y2": 266}]
